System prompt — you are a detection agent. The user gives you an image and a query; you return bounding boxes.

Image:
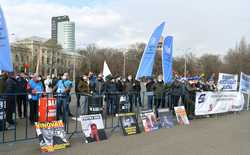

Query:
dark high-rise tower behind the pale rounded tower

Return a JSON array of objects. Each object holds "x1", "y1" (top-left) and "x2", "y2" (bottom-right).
[{"x1": 51, "y1": 15, "x2": 69, "y2": 41}]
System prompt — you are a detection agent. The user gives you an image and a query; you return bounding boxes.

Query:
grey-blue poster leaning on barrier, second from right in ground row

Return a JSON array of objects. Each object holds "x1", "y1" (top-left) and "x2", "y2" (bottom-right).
[{"x1": 158, "y1": 108, "x2": 174, "y2": 128}]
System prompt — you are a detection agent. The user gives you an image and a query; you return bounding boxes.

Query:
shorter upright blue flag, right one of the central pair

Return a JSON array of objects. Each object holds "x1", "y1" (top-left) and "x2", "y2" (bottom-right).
[{"x1": 162, "y1": 36, "x2": 173, "y2": 83}]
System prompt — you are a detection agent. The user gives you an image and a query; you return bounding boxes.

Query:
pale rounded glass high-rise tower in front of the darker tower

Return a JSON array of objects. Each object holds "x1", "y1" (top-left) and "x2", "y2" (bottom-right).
[{"x1": 57, "y1": 21, "x2": 75, "y2": 52}]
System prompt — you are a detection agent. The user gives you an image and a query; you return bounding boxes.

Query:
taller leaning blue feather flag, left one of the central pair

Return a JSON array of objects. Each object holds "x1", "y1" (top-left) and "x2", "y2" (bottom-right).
[{"x1": 135, "y1": 22, "x2": 165, "y2": 80}]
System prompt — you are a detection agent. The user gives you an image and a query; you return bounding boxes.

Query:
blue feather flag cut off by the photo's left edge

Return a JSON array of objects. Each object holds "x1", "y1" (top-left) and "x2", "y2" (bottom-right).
[{"x1": 0, "y1": 6, "x2": 13, "y2": 72}]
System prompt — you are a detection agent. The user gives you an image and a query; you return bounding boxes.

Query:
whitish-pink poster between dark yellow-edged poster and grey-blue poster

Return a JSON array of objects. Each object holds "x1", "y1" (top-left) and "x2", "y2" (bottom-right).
[{"x1": 141, "y1": 110, "x2": 159, "y2": 132}]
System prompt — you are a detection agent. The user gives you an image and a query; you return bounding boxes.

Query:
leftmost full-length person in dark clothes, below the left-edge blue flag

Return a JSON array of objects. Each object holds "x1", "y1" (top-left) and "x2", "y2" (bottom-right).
[{"x1": 5, "y1": 72, "x2": 17, "y2": 129}]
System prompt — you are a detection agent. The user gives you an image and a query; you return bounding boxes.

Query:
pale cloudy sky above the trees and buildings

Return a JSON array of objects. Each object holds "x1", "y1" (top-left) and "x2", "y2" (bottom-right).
[{"x1": 0, "y1": 0, "x2": 250, "y2": 55}]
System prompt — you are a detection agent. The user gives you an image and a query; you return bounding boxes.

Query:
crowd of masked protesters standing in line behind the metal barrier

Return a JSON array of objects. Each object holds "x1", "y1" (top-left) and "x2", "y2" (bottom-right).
[{"x1": 0, "y1": 72, "x2": 216, "y2": 129}]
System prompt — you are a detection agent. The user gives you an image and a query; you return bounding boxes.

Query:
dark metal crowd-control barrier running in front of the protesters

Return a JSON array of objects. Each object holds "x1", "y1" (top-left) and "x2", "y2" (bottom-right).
[{"x1": 0, "y1": 92, "x2": 247, "y2": 144}]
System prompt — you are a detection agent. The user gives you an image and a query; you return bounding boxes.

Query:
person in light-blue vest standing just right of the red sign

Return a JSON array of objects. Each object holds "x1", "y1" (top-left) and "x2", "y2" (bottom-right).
[{"x1": 54, "y1": 73, "x2": 72, "y2": 124}]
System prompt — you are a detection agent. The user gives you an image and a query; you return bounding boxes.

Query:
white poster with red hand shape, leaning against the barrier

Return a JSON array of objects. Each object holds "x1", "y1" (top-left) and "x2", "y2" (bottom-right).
[{"x1": 80, "y1": 114, "x2": 107, "y2": 143}]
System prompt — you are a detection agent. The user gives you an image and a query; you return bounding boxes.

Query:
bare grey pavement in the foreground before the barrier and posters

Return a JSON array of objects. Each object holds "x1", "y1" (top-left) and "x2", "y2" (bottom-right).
[{"x1": 0, "y1": 111, "x2": 250, "y2": 155}]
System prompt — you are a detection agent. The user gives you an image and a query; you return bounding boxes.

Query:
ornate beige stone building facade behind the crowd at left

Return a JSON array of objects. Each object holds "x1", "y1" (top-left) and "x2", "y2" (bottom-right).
[{"x1": 11, "y1": 37, "x2": 82, "y2": 77}]
